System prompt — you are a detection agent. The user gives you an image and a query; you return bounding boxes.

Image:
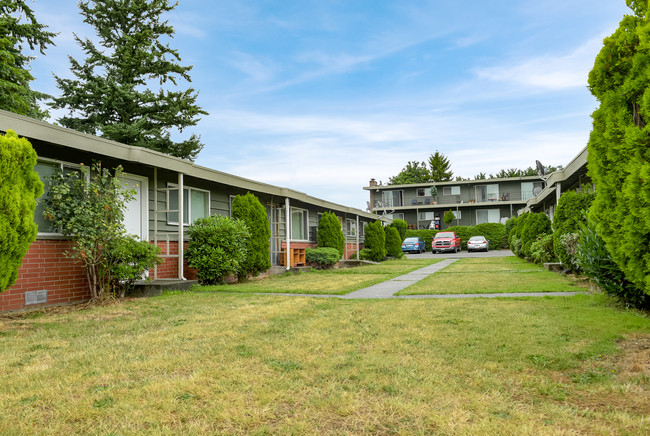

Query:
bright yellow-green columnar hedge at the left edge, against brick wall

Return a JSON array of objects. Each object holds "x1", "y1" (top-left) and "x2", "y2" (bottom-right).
[{"x1": 0, "y1": 130, "x2": 43, "y2": 292}]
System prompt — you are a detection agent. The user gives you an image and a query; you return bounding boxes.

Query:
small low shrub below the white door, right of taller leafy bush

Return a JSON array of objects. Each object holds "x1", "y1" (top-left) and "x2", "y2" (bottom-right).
[{"x1": 106, "y1": 236, "x2": 162, "y2": 298}]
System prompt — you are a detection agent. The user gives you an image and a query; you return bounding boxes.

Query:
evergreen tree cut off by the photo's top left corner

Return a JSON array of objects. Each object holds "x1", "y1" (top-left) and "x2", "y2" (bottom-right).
[{"x1": 0, "y1": 0, "x2": 56, "y2": 119}]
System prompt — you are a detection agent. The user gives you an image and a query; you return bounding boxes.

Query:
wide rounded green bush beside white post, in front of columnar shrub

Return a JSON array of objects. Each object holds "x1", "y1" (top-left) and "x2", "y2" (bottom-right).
[{"x1": 185, "y1": 215, "x2": 250, "y2": 284}]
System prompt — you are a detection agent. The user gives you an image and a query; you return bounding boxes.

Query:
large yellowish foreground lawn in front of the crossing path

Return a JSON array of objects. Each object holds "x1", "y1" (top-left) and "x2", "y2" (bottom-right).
[{"x1": 0, "y1": 292, "x2": 650, "y2": 435}]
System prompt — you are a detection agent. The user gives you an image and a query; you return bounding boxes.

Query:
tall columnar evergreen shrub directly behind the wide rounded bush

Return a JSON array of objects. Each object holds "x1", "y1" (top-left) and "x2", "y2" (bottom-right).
[{"x1": 232, "y1": 192, "x2": 271, "y2": 278}]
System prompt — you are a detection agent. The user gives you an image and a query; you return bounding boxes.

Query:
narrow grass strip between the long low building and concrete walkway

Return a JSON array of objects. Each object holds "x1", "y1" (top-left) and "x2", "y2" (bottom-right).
[{"x1": 196, "y1": 259, "x2": 440, "y2": 295}]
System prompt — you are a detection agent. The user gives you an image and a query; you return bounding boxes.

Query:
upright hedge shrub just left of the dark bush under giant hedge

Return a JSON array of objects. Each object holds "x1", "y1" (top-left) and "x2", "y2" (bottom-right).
[{"x1": 553, "y1": 190, "x2": 594, "y2": 268}]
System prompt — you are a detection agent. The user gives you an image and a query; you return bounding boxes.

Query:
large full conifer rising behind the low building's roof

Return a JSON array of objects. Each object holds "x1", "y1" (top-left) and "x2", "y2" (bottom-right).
[{"x1": 52, "y1": 0, "x2": 207, "y2": 160}]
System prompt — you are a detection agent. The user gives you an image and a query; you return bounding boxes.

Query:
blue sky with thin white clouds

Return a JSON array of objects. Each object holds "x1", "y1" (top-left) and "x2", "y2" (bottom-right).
[{"x1": 31, "y1": 0, "x2": 631, "y2": 210}]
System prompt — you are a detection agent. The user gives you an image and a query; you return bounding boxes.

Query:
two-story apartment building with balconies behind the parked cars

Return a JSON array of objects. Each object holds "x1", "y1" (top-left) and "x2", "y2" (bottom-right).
[{"x1": 363, "y1": 176, "x2": 545, "y2": 229}]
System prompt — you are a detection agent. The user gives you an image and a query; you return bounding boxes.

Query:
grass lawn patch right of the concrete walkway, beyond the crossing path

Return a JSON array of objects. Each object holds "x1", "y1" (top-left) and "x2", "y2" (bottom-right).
[{"x1": 398, "y1": 257, "x2": 585, "y2": 295}]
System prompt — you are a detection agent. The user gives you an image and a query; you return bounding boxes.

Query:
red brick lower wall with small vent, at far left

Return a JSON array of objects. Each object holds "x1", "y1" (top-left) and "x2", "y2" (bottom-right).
[{"x1": 0, "y1": 240, "x2": 90, "y2": 312}]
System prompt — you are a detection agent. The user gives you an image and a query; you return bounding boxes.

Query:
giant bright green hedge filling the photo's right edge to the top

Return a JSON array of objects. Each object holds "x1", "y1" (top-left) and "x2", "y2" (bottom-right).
[{"x1": 587, "y1": 0, "x2": 650, "y2": 294}]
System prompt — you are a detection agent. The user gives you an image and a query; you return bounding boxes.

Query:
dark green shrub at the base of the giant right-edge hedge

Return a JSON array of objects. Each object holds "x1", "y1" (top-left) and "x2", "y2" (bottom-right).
[{"x1": 576, "y1": 223, "x2": 650, "y2": 308}]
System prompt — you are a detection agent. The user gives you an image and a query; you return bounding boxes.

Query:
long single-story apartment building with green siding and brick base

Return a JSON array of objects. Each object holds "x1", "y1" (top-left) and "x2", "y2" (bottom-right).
[{"x1": 0, "y1": 110, "x2": 390, "y2": 312}]
